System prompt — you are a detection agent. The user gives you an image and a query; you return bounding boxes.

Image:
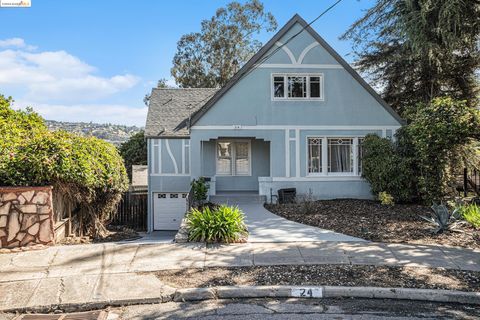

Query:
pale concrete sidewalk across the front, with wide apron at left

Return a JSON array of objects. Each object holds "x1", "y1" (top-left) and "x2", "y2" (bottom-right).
[{"x1": 0, "y1": 241, "x2": 480, "y2": 311}]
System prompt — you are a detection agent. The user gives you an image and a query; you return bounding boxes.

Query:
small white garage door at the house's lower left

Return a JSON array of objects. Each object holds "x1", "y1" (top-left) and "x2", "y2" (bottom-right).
[{"x1": 153, "y1": 192, "x2": 187, "y2": 230}]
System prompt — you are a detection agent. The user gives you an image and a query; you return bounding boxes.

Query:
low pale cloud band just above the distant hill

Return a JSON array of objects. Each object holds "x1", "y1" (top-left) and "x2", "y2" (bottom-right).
[{"x1": 14, "y1": 100, "x2": 148, "y2": 127}]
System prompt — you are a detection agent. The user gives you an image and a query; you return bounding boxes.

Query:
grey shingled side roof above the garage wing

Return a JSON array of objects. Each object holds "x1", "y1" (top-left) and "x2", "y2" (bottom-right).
[{"x1": 145, "y1": 88, "x2": 218, "y2": 137}]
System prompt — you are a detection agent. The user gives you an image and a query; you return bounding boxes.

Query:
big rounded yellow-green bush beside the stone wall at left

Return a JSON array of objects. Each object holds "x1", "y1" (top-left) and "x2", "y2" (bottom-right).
[{"x1": 0, "y1": 95, "x2": 128, "y2": 236}]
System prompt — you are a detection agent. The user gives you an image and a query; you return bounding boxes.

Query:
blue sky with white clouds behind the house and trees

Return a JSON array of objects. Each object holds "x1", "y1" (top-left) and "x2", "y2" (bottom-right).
[{"x1": 0, "y1": 0, "x2": 374, "y2": 126}]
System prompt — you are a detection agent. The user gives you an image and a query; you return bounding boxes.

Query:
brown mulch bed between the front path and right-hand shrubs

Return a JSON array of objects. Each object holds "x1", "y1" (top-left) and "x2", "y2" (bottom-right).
[{"x1": 265, "y1": 199, "x2": 480, "y2": 248}]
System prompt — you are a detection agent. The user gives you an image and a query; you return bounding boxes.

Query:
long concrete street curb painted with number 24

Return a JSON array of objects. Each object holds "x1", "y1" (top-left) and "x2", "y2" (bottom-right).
[{"x1": 0, "y1": 286, "x2": 480, "y2": 313}]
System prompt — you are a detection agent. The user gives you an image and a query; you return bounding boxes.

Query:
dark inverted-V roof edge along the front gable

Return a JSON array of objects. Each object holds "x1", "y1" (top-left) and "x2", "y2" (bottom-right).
[{"x1": 190, "y1": 14, "x2": 404, "y2": 126}]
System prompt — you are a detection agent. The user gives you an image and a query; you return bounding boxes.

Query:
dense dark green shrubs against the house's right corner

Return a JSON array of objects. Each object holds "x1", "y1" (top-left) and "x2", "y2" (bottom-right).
[{"x1": 362, "y1": 97, "x2": 480, "y2": 203}]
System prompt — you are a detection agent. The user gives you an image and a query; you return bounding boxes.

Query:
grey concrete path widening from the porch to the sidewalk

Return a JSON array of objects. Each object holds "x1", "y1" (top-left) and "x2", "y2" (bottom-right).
[{"x1": 231, "y1": 201, "x2": 365, "y2": 242}]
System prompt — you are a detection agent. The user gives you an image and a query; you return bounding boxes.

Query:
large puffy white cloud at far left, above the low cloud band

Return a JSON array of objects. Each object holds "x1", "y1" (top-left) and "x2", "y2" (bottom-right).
[{"x1": 0, "y1": 38, "x2": 140, "y2": 105}]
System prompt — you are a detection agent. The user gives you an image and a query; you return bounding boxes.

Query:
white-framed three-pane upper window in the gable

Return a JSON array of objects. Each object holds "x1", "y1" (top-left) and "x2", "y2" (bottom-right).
[{"x1": 272, "y1": 73, "x2": 323, "y2": 100}]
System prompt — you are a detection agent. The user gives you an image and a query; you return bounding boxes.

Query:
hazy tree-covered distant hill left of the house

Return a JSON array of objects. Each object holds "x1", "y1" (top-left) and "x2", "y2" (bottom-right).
[{"x1": 45, "y1": 120, "x2": 143, "y2": 145}]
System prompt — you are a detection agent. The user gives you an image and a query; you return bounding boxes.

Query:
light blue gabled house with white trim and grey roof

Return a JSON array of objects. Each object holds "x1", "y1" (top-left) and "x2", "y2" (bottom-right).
[{"x1": 145, "y1": 15, "x2": 402, "y2": 230}]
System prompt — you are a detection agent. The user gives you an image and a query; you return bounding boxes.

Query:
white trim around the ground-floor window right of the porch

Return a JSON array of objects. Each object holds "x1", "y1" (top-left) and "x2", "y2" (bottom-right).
[{"x1": 305, "y1": 135, "x2": 365, "y2": 178}]
